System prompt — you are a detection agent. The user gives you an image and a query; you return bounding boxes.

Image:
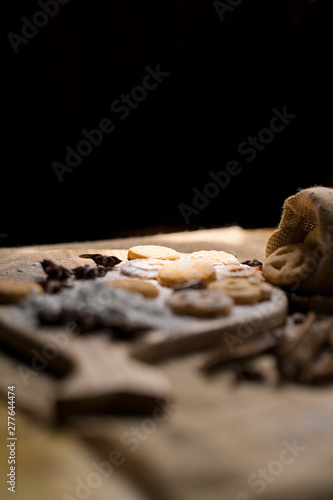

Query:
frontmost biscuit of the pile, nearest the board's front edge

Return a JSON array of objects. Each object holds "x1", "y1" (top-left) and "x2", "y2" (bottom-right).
[{"x1": 166, "y1": 289, "x2": 234, "y2": 316}]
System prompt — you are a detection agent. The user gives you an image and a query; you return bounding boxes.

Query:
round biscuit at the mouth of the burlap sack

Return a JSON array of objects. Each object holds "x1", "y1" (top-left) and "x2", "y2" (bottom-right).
[{"x1": 262, "y1": 244, "x2": 314, "y2": 286}]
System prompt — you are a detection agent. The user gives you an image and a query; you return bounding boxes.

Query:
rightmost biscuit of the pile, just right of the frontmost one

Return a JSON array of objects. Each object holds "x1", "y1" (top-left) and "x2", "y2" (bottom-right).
[{"x1": 208, "y1": 278, "x2": 263, "y2": 304}]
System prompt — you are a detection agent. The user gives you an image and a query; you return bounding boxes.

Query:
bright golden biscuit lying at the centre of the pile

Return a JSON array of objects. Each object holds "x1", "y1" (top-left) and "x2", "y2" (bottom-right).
[{"x1": 157, "y1": 259, "x2": 216, "y2": 287}]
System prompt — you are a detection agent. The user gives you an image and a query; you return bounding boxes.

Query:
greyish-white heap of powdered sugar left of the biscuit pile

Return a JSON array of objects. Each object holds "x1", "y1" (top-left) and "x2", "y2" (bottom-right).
[{"x1": 22, "y1": 279, "x2": 196, "y2": 330}]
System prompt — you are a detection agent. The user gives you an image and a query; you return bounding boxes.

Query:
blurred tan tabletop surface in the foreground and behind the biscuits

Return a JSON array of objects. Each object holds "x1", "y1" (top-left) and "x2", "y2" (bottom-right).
[{"x1": 0, "y1": 227, "x2": 333, "y2": 500}]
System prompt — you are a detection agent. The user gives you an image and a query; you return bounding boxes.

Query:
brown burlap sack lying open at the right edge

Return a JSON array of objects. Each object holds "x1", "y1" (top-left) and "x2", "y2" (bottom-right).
[{"x1": 266, "y1": 186, "x2": 333, "y2": 295}]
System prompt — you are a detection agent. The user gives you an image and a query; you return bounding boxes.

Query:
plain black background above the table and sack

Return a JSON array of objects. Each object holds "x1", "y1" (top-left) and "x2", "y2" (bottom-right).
[{"x1": 0, "y1": 0, "x2": 333, "y2": 246}]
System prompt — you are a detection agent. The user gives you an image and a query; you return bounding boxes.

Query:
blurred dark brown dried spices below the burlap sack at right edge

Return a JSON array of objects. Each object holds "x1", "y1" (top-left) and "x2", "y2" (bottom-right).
[{"x1": 200, "y1": 312, "x2": 333, "y2": 385}]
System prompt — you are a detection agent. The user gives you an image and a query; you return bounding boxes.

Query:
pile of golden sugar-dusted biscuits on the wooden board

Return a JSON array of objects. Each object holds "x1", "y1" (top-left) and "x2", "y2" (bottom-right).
[{"x1": 115, "y1": 245, "x2": 273, "y2": 317}]
